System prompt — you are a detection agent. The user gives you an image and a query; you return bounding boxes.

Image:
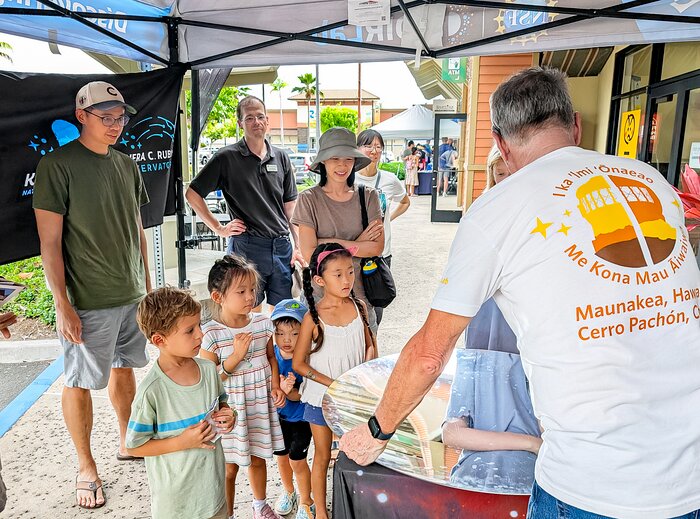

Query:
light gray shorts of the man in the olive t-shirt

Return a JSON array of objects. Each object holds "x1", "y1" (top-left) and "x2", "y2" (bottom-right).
[{"x1": 58, "y1": 304, "x2": 148, "y2": 389}]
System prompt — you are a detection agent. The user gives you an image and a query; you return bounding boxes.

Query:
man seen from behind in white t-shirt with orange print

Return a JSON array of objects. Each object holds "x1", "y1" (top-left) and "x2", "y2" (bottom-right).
[{"x1": 341, "y1": 68, "x2": 700, "y2": 519}]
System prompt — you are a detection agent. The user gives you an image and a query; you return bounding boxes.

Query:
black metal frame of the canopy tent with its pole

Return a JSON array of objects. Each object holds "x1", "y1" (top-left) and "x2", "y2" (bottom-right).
[{"x1": 0, "y1": 0, "x2": 700, "y2": 288}]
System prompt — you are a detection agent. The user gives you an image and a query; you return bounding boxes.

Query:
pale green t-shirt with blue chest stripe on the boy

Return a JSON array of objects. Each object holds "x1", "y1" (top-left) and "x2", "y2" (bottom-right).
[{"x1": 126, "y1": 358, "x2": 228, "y2": 519}]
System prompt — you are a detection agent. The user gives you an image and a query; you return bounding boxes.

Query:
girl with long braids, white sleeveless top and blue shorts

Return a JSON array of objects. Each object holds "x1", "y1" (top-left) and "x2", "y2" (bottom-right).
[{"x1": 292, "y1": 243, "x2": 377, "y2": 519}]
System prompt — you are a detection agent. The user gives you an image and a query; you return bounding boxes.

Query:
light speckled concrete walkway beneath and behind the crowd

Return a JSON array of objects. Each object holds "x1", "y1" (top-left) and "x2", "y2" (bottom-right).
[{"x1": 0, "y1": 197, "x2": 456, "y2": 519}]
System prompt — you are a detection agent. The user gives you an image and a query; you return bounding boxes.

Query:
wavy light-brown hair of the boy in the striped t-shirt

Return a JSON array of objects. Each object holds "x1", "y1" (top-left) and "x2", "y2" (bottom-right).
[{"x1": 136, "y1": 287, "x2": 202, "y2": 339}]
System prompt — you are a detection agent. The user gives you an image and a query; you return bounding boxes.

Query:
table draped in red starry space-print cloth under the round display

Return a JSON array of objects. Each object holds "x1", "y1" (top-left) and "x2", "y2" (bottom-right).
[{"x1": 333, "y1": 452, "x2": 529, "y2": 519}]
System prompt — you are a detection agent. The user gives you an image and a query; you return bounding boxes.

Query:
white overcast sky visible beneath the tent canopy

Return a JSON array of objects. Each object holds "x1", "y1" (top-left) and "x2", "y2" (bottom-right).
[{"x1": 0, "y1": 33, "x2": 426, "y2": 109}]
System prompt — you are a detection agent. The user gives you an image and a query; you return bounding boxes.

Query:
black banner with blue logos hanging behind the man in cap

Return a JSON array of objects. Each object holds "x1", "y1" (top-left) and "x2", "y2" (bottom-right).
[{"x1": 0, "y1": 69, "x2": 184, "y2": 264}]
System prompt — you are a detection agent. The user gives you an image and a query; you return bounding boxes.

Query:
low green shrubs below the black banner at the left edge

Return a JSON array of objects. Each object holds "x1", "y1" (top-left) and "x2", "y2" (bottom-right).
[{"x1": 0, "y1": 257, "x2": 56, "y2": 326}]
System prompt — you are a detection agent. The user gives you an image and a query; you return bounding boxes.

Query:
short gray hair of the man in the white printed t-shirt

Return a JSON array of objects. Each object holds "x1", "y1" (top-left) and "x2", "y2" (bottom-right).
[{"x1": 490, "y1": 67, "x2": 575, "y2": 143}]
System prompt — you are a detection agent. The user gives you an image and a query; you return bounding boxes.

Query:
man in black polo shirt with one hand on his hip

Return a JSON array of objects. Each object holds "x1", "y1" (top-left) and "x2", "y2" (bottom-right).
[{"x1": 185, "y1": 96, "x2": 303, "y2": 305}]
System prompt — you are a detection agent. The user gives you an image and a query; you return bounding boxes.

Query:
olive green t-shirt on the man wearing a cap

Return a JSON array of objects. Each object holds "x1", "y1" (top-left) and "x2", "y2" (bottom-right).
[{"x1": 33, "y1": 140, "x2": 148, "y2": 310}]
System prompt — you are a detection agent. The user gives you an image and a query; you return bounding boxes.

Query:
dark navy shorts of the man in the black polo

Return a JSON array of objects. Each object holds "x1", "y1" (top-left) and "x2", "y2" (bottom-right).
[{"x1": 226, "y1": 234, "x2": 292, "y2": 306}]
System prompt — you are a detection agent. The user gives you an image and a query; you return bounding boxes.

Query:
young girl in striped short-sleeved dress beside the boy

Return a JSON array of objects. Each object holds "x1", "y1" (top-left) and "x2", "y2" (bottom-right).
[{"x1": 200, "y1": 255, "x2": 285, "y2": 519}]
